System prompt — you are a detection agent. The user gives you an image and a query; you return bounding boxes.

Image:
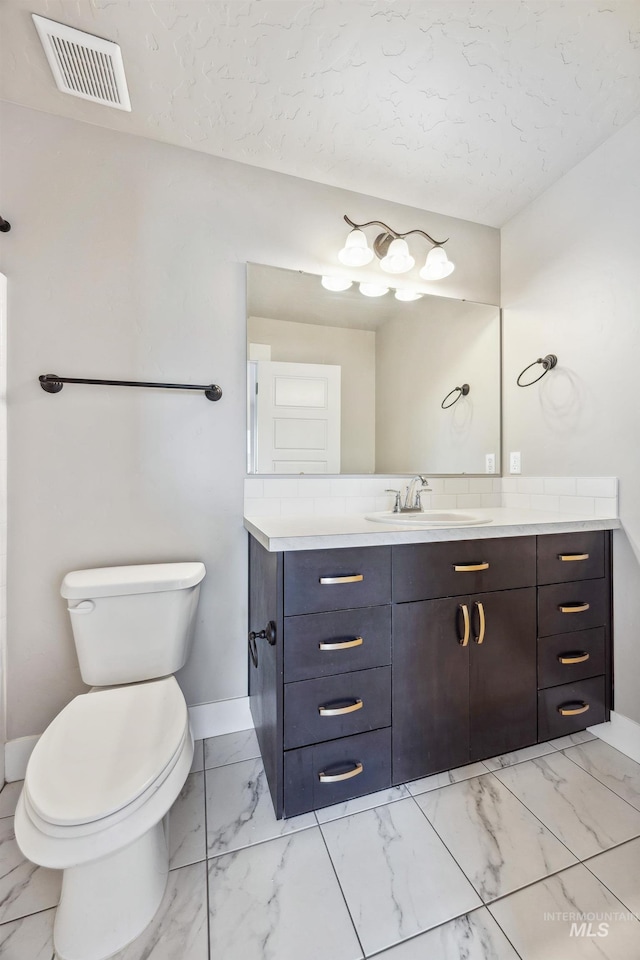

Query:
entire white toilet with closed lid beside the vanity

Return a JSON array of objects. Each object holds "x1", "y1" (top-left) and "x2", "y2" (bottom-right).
[{"x1": 15, "y1": 563, "x2": 205, "y2": 960}]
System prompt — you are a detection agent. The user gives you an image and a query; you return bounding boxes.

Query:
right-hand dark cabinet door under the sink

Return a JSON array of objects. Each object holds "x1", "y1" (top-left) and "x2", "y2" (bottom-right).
[{"x1": 469, "y1": 587, "x2": 537, "y2": 760}]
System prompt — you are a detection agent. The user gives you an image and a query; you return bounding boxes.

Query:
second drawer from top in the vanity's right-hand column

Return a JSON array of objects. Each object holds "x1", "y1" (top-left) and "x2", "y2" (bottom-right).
[{"x1": 538, "y1": 580, "x2": 609, "y2": 637}]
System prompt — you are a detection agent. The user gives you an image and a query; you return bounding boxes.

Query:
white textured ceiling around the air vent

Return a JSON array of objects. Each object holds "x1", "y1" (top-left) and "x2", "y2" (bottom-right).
[{"x1": 0, "y1": 0, "x2": 640, "y2": 226}]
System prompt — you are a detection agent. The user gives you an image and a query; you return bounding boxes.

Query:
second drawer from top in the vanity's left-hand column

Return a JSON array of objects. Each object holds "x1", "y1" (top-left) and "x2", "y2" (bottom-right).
[{"x1": 284, "y1": 604, "x2": 391, "y2": 682}]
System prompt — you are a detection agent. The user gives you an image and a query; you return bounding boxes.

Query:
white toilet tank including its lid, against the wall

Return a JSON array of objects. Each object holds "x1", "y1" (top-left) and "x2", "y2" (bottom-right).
[{"x1": 60, "y1": 562, "x2": 206, "y2": 687}]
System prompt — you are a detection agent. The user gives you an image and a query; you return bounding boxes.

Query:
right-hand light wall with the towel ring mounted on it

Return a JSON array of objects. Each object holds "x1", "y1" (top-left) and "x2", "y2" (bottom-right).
[{"x1": 502, "y1": 119, "x2": 640, "y2": 722}]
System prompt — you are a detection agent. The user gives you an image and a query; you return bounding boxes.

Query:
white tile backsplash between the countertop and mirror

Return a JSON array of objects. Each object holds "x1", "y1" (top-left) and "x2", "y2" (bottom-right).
[{"x1": 244, "y1": 476, "x2": 618, "y2": 517}]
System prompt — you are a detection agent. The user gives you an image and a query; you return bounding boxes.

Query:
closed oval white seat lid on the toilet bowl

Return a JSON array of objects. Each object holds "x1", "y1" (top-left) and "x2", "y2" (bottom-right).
[{"x1": 25, "y1": 676, "x2": 189, "y2": 824}]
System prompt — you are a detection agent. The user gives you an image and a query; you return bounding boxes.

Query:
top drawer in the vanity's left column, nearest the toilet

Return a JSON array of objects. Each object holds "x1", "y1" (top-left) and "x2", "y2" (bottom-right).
[{"x1": 284, "y1": 547, "x2": 391, "y2": 617}]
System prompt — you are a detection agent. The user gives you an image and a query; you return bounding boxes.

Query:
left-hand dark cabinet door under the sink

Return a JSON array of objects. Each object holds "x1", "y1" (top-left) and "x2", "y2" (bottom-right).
[{"x1": 392, "y1": 590, "x2": 470, "y2": 783}]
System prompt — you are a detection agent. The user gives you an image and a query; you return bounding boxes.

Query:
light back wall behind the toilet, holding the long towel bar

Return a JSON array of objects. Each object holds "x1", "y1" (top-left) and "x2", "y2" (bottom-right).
[{"x1": 0, "y1": 104, "x2": 499, "y2": 738}]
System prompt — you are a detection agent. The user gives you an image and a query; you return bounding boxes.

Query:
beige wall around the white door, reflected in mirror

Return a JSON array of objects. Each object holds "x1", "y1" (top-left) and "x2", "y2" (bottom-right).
[{"x1": 248, "y1": 317, "x2": 376, "y2": 473}]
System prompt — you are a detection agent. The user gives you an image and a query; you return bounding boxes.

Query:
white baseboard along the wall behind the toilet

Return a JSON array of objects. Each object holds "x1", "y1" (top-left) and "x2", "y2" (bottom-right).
[{"x1": 4, "y1": 697, "x2": 253, "y2": 783}]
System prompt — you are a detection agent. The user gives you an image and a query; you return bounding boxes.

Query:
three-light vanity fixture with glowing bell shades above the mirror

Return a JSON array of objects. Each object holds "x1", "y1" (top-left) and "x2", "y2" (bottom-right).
[{"x1": 338, "y1": 214, "x2": 454, "y2": 280}]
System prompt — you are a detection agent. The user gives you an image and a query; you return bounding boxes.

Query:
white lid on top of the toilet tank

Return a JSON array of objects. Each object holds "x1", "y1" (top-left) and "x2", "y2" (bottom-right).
[{"x1": 60, "y1": 561, "x2": 206, "y2": 600}]
